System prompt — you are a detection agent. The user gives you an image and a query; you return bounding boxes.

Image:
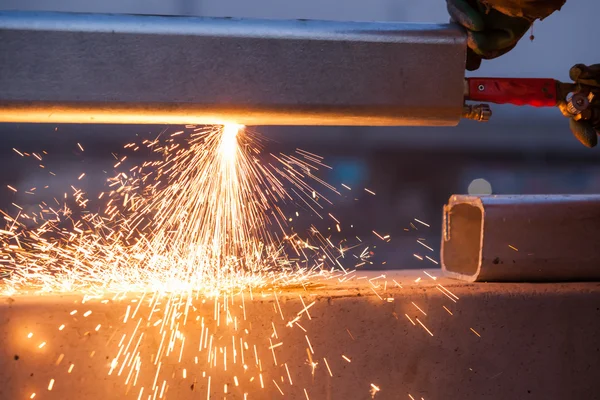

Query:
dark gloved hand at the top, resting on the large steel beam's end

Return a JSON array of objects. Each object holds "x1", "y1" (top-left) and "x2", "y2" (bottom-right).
[{"x1": 446, "y1": 0, "x2": 535, "y2": 71}]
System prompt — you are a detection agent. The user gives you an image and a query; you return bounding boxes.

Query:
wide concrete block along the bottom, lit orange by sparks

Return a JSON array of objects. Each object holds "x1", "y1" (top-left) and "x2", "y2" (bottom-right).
[{"x1": 0, "y1": 271, "x2": 600, "y2": 400}]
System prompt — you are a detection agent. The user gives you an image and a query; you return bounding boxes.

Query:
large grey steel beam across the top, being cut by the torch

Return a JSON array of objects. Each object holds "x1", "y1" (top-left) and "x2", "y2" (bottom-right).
[{"x1": 0, "y1": 11, "x2": 466, "y2": 126}]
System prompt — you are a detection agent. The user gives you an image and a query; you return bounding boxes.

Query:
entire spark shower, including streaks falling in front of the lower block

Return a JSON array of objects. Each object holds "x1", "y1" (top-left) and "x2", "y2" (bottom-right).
[{"x1": 0, "y1": 125, "x2": 384, "y2": 398}]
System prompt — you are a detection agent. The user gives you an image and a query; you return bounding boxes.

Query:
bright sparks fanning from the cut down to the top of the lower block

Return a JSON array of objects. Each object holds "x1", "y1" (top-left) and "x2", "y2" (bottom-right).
[{"x1": 0, "y1": 125, "x2": 369, "y2": 294}]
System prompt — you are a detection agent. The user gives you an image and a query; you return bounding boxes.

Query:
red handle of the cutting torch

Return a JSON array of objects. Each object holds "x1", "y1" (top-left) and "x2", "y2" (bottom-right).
[{"x1": 465, "y1": 78, "x2": 558, "y2": 107}]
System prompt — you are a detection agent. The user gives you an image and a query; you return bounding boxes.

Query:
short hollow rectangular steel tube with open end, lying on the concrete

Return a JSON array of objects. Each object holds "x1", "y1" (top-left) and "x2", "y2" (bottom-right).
[{"x1": 441, "y1": 195, "x2": 600, "y2": 282}]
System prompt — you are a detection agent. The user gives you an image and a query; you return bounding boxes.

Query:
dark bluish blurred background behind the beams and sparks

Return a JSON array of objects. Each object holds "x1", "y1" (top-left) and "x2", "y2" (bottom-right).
[{"x1": 0, "y1": 0, "x2": 600, "y2": 269}]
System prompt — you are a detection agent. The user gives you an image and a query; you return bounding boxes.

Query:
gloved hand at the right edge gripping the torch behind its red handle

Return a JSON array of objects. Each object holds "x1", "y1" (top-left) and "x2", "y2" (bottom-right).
[{"x1": 558, "y1": 64, "x2": 600, "y2": 147}]
